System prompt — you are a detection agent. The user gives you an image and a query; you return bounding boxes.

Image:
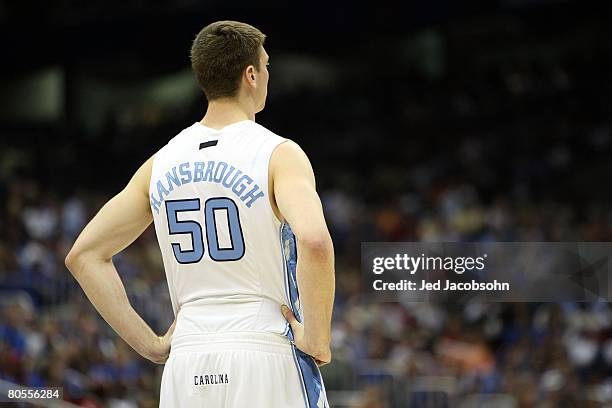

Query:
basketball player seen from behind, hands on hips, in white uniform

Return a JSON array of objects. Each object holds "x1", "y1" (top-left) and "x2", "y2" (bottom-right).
[{"x1": 66, "y1": 21, "x2": 334, "y2": 408}]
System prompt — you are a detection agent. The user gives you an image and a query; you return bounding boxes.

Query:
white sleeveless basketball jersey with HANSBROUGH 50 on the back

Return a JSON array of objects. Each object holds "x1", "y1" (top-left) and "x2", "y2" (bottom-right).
[{"x1": 149, "y1": 120, "x2": 297, "y2": 335}]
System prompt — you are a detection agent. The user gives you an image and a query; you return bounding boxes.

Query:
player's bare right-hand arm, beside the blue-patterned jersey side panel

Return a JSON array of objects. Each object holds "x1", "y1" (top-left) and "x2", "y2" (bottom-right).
[{"x1": 270, "y1": 141, "x2": 335, "y2": 365}]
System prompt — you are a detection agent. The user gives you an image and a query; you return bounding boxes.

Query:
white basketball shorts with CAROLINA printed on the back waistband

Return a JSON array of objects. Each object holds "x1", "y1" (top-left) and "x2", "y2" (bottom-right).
[{"x1": 159, "y1": 332, "x2": 329, "y2": 408}]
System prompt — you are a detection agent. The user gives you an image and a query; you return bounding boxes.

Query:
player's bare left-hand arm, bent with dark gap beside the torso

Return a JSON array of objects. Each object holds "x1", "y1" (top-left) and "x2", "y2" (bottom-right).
[{"x1": 66, "y1": 158, "x2": 176, "y2": 363}]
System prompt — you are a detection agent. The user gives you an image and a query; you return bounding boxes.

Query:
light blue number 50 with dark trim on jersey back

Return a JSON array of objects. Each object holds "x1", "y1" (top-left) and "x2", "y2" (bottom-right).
[{"x1": 166, "y1": 197, "x2": 244, "y2": 264}]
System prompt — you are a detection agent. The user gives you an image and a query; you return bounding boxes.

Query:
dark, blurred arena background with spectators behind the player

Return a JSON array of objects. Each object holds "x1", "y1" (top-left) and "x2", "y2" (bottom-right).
[{"x1": 0, "y1": 0, "x2": 612, "y2": 408}]
